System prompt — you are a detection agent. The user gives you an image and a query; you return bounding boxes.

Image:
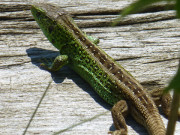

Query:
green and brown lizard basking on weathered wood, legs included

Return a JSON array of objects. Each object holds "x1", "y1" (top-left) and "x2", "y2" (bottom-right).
[{"x1": 31, "y1": 4, "x2": 176, "y2": 135}]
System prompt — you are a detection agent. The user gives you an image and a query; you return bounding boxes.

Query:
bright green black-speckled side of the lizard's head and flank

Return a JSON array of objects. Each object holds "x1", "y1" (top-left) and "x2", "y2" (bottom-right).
[{"x1": 31, "y1": 3, "x2": 121, "y2": 105}]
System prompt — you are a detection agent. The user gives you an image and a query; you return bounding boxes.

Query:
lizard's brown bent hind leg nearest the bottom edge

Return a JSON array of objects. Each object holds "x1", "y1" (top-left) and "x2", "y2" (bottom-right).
[{"x1": 110, "y1": 100, "x2": 128, "y2": 135}]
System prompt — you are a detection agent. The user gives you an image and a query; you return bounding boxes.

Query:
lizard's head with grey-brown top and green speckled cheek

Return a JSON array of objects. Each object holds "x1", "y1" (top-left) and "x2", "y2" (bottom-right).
[{"x1": 31, "y1": 4, "x2": 73, "y2": 50}]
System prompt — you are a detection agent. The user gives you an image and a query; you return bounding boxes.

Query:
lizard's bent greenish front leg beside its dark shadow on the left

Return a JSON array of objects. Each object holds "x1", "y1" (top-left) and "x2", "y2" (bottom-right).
[{"x1": 40, "y1": 55, "x2": 68, "y2": 72}]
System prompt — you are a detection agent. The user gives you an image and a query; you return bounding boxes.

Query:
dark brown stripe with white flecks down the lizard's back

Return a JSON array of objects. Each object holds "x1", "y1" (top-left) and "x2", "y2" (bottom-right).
[{"x1": 62, "y1": 13, "x2": 147, "y2": 99}]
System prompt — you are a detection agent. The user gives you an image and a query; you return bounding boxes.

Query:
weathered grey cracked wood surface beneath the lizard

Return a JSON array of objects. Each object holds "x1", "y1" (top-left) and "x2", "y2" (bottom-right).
[{"x1": 0, "y1": 0, "x2": 180, "y2": 135}]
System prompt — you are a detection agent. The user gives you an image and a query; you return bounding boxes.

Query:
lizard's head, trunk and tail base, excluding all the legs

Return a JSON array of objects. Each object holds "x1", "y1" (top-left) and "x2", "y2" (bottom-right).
[{"x1": 31, "y1": 4, "x2": 165, "y2": 135}]
